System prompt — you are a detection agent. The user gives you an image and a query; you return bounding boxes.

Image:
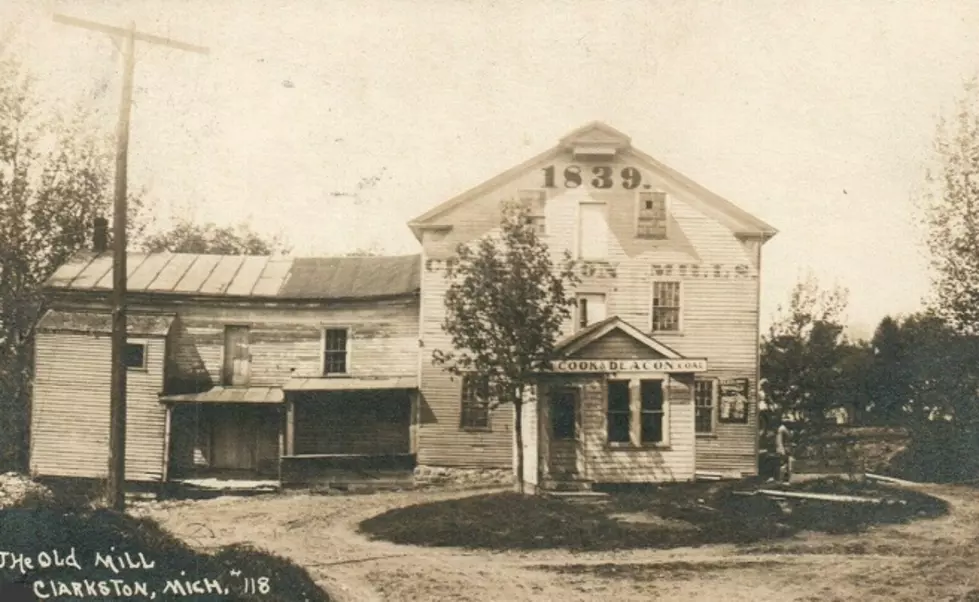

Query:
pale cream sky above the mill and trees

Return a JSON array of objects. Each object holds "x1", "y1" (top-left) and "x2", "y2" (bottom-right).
[{"x1": 0, "y1": 0, "x2": 979, "y2": 336}]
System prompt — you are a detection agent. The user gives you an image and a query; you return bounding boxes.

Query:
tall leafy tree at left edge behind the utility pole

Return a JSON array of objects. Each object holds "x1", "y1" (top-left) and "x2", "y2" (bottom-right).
[{"x1": 0, "y1": 51, "x2": 145, "y2": 469}]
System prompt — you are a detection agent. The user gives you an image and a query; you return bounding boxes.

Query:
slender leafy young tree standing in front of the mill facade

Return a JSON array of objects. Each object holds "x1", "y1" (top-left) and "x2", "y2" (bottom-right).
[{"x1": 433, "y1": 203, "x2": 578, "y2": 492}]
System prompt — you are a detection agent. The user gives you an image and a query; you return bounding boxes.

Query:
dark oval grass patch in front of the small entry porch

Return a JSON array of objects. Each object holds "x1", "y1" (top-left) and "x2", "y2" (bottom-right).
[{"x1": 360, "y1": 479, "x2": 948, "y2": 551}]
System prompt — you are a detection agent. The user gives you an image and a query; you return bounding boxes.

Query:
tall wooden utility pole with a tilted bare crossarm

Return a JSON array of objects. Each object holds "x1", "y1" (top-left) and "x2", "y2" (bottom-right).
[{"x1": 54, "y1": 14, "x2": 209, "y2": 511}]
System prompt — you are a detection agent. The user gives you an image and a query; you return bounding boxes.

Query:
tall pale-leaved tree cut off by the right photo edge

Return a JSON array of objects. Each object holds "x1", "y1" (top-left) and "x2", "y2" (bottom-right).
[{"x1": 919, "y1": 79, "x2": 979, "y2": 334}]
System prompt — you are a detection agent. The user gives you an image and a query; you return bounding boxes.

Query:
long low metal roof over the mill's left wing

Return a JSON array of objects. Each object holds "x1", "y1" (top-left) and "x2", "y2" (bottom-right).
[{"x1": 45, "y1": 252, "x2": 421, "y2": 300}]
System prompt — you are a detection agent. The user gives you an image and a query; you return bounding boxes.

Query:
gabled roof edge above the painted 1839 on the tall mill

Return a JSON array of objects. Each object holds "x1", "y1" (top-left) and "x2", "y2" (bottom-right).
[{"x1": 408, "y1": 121, "x2": 778, "y2": 240}]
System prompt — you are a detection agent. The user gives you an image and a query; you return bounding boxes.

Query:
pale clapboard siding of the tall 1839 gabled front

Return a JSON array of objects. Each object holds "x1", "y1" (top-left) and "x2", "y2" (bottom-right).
[{"x1": 420, "y1": 144, "x2": 759, "y2": 480}]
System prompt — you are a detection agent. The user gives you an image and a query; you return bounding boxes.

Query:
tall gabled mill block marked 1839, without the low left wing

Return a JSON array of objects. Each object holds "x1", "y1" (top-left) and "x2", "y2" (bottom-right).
[{"x1": 409, "y1": 123, "x2": 775, "y2": 486}]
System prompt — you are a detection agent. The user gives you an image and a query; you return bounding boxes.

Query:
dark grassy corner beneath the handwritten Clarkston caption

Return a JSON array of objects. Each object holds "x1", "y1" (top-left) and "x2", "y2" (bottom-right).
[{"x1": 0, "y1": 500, "x2": 330, "y2": 602}]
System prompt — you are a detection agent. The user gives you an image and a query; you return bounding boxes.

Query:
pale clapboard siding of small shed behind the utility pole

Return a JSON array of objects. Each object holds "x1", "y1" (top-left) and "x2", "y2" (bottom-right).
[{"x1": 31, "y1": 333, "x2": 165, "y2": 481}]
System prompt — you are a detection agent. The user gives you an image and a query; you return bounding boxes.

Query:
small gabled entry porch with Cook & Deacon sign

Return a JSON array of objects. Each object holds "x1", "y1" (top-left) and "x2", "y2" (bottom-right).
[{"x1": 524, "y1": 316, "x2": 707, "y2": 490}]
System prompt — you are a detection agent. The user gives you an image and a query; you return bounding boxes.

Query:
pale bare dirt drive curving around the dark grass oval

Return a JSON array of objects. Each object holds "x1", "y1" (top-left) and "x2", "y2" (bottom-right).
[{"x1": 132, "y1": 486, "x2": 979, "y2": 602}]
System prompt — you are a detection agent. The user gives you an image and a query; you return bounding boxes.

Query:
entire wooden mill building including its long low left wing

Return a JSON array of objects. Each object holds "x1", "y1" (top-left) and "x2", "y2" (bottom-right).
[{"x1": 31, "y1": 123, "x2": 775, "y2": 488}]
